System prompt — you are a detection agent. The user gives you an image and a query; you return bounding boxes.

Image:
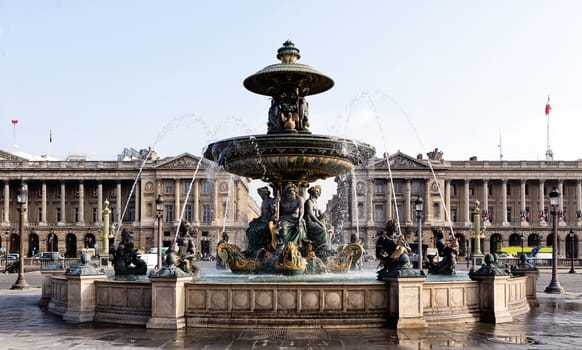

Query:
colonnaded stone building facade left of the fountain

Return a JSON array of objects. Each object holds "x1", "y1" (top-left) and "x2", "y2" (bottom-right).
[{"x1": 0, "y1": 152, "x2": 258, "y2": 257}]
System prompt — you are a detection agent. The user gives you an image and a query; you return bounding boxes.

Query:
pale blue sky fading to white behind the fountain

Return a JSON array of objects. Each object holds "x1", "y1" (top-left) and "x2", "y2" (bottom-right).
[{"x1": 0, "y1": 0, "x2": 582, "y2": 167}]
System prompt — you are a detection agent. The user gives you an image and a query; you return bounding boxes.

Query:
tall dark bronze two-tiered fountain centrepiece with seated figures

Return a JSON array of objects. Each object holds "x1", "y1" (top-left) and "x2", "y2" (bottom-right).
[{"x1": 204, "y1": 41, "x2": 375, "y2": 274}]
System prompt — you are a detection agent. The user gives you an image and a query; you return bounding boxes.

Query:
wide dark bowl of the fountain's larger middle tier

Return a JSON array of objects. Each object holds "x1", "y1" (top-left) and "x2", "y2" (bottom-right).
[{"x1": 204, "y1": 133, "x2": 376, "y2": 183}]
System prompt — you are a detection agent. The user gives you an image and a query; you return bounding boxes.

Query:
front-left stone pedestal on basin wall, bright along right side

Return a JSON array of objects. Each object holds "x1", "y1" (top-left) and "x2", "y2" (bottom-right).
[{"x1": 146, "y1": 276, "x2": 192, "y2": 329}]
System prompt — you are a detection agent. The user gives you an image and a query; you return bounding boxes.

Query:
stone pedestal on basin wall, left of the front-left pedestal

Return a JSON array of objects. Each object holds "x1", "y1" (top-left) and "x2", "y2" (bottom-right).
[{"x1": 63, "y1": 275, "x2": 107, "y2": 323}]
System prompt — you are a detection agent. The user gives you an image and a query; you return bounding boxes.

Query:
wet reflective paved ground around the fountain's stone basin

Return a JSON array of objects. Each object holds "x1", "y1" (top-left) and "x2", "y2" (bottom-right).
[{"x1": 0, "y1": 269, "x2": 582, "y2": 350}]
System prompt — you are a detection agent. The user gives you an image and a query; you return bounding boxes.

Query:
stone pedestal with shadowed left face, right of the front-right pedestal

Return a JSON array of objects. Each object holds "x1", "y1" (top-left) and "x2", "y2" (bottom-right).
[{"x1": 471, "y1": 275, "x2": 513, "y2": 323}]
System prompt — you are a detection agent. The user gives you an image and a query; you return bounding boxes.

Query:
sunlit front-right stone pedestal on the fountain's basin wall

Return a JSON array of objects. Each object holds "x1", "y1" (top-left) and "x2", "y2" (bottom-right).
[{"x1": 384, "y1": 276, "x2": 427, "y2": 328}]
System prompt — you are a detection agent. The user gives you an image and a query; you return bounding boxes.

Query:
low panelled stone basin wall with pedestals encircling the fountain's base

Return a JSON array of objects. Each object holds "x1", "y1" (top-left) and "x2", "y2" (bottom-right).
[{"x1": 43, "y1": 275, "x2": 535, "y2": 329}]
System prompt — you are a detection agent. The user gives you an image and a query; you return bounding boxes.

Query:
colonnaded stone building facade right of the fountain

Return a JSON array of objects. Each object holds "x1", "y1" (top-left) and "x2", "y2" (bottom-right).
[{"x1": 327, "y1": 150, "x2": 582, "y2": 258}]
